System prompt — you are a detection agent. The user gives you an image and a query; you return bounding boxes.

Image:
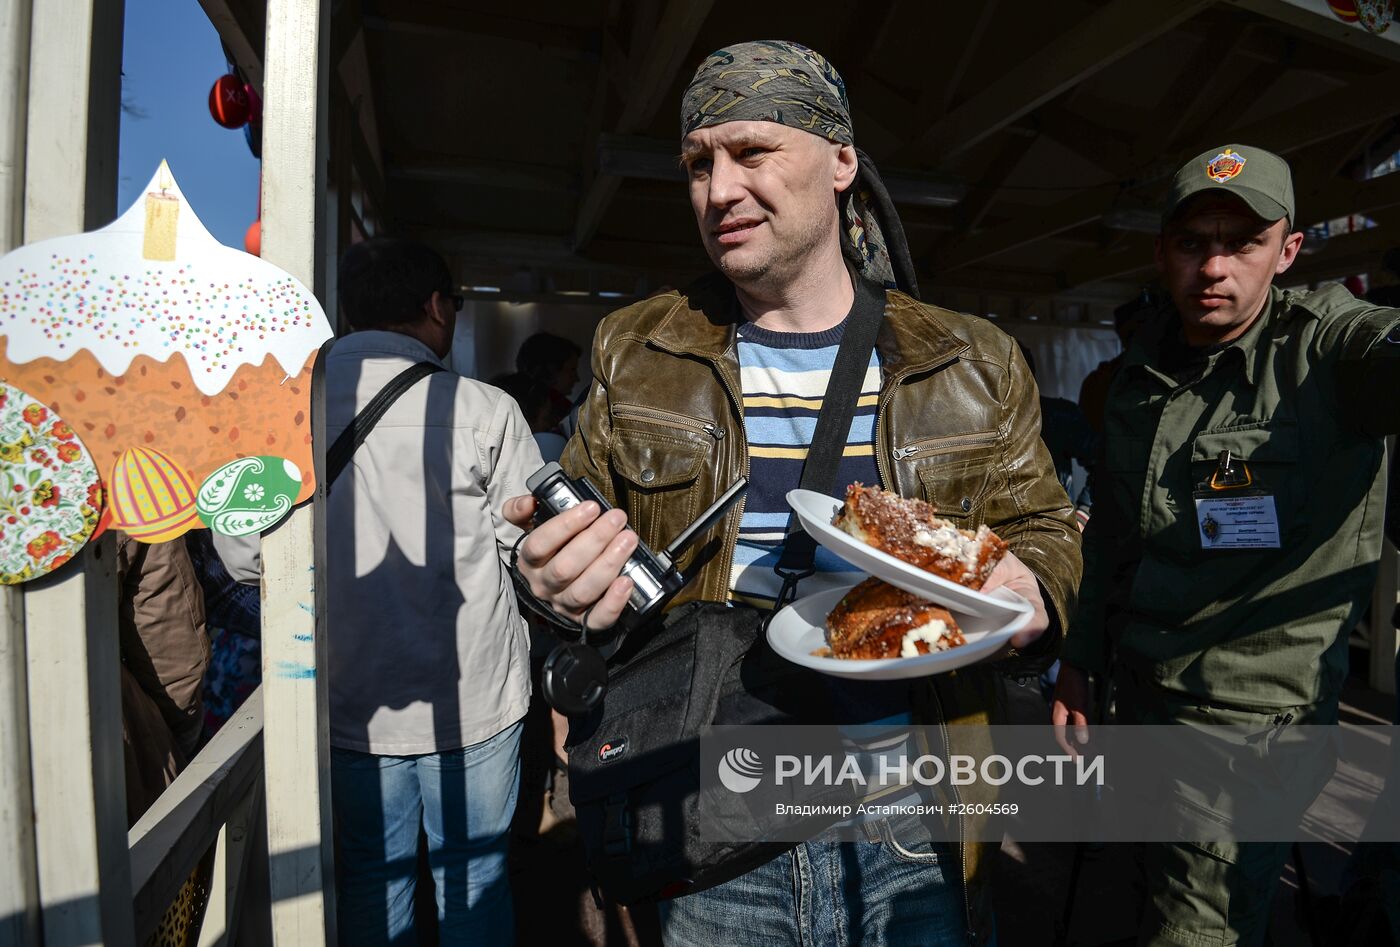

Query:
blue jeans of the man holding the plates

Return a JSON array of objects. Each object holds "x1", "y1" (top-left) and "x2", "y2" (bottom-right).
[{"x1": 661, "y1": 815, "x2": 967, "y2": 947}]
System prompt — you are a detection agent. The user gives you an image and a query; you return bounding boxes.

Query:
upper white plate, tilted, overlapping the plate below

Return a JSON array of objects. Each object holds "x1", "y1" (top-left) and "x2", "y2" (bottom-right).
[{"x1": 787, "y1": 490, "x2": 1030, "y2": 625}]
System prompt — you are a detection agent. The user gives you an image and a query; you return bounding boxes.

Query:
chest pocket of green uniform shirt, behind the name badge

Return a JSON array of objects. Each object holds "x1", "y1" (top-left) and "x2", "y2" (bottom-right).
[{"x1": 1189, "y1": 420, "x2": 1308, "y2": 537}]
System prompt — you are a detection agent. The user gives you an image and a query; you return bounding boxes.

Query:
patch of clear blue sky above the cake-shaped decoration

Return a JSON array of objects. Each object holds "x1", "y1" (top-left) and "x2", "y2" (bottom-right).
[{"x1": 118, "y1": 0, "x2": 259, "y2": 249}]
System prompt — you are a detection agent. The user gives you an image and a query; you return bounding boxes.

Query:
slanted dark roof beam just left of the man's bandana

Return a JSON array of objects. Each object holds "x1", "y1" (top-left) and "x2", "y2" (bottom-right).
[{"x1": 573, "y1": 0, "x2": 714, "y2": 249}]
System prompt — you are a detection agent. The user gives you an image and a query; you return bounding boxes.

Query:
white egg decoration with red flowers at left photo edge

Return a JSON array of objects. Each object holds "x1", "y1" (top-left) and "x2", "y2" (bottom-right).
[{"x1": 0, "y1": 382, "x2": 102, "y2": 586}]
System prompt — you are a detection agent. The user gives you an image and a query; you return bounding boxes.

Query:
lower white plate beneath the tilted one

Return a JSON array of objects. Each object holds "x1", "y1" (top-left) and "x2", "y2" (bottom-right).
[{"x1": 769, "y1": 588, "x2": 1030, "y2": 681}]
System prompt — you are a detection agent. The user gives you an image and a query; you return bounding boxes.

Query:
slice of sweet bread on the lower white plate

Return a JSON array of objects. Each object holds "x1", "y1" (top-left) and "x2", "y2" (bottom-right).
[{"x1": 826, "y1": 579, "x2": 966, "y2": 660}]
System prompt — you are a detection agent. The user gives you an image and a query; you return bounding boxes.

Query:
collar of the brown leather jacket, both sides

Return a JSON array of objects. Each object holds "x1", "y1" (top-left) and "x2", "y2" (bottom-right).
[{"x1": 647, "y1": 273, "x2": 967, "y2": 377}]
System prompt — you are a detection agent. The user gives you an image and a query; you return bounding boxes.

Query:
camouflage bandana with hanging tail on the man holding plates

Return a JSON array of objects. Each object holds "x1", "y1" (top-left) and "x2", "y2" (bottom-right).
[{"x1": 680, "y1": 39, "x2": 918, "y2": 296}]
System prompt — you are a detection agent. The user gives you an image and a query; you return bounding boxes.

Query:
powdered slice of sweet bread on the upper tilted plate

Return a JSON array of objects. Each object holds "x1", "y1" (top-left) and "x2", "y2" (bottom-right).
[{"x1": 832, "y1": 483, "x2": 1007, "y2": 588}]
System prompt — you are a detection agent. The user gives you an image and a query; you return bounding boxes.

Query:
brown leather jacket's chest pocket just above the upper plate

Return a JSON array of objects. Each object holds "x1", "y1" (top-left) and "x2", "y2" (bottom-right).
[{"x1": 895, "y1": 431, "x2": 1005, "y2": 530}]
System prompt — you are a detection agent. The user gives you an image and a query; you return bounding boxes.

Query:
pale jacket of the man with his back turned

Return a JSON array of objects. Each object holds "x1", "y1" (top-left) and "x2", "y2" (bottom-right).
[{"x1": 324, "y1": 332, "x2": 540, "y2": 756}]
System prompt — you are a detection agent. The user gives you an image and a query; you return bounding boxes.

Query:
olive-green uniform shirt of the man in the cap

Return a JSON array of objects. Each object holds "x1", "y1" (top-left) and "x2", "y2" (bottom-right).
[{"x1": 1063, "y1": 286, "x2": 1400, "y2": 710}]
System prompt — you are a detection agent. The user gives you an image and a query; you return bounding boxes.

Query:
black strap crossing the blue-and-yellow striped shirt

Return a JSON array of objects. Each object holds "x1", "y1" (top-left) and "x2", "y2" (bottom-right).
[{"x1": 773, "y1": 275, "x2": 885, "y2": 612}]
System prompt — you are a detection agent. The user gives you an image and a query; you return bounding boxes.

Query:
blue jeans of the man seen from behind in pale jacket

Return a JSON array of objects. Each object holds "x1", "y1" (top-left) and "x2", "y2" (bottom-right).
[{"x1": 330, "y1": 723, "x2": 524, "y2": 946}]
